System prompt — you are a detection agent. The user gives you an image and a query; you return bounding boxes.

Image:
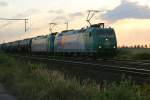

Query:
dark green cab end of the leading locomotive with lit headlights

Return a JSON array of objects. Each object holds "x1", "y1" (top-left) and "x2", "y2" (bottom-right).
[{"x1": 92, "y1": 25, "x2": 117, "y2": 56}]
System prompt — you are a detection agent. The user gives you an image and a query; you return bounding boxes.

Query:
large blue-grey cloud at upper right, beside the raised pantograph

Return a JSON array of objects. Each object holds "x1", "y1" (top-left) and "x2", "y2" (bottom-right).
[{"x1": 102, "y1": 0, "x2": 150, "y2": 22}]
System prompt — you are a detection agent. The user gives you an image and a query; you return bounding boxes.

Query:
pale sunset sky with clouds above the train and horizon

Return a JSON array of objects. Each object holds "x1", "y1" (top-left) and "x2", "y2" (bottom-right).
[{"x1": 0, "y1": 0, "x2": 150, "y2": 46}]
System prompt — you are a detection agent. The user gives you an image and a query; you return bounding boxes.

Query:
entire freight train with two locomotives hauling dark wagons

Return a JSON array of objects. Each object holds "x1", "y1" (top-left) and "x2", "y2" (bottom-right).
[{"x1": 2, "y1": 23, "x2": 117, "y2": 57}]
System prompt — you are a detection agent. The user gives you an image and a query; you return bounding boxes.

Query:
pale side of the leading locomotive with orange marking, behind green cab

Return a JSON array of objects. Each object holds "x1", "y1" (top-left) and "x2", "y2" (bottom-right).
[{"x1": 55, "y1": 31, "x2": 86, "y2": 52}]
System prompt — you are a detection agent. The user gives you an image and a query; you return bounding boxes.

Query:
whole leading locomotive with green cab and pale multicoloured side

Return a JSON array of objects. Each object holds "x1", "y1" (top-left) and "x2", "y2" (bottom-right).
[{"x1": 54, "y1": 23, "x2": 117, "y2": 56}]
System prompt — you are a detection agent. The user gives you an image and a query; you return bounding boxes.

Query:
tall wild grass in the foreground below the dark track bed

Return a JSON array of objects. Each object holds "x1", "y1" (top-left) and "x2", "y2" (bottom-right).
[{"x1": 0, "y1": 52, "x2": 150, "y2": 100}]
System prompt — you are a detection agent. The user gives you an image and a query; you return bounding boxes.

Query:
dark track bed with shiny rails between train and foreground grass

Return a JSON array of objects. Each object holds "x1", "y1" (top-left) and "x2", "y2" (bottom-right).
[{"x1": 10, "y1": 55, "x2": 150, "y2": 82}]
